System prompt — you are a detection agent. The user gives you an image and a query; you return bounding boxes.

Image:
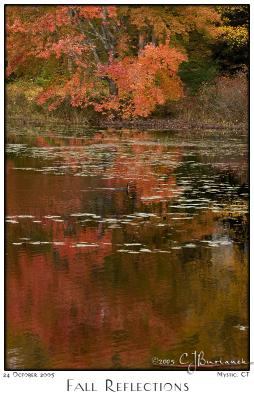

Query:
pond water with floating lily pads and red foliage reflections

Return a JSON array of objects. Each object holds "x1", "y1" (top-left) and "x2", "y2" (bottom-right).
[{"x1": 5, "y1": 126, "x2": 249, "y2": 370}]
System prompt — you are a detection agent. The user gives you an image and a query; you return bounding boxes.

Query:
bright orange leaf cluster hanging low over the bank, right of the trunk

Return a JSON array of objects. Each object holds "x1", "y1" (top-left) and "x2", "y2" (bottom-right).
[{"x1": 96, "y1": 44, "x2": 186, "y2": 117}]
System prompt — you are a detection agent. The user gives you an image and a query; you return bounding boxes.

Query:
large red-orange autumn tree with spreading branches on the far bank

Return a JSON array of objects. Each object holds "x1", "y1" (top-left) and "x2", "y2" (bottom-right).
[{"x1": 6, "y1": 5, "x2": 220, "y2": 118}]
